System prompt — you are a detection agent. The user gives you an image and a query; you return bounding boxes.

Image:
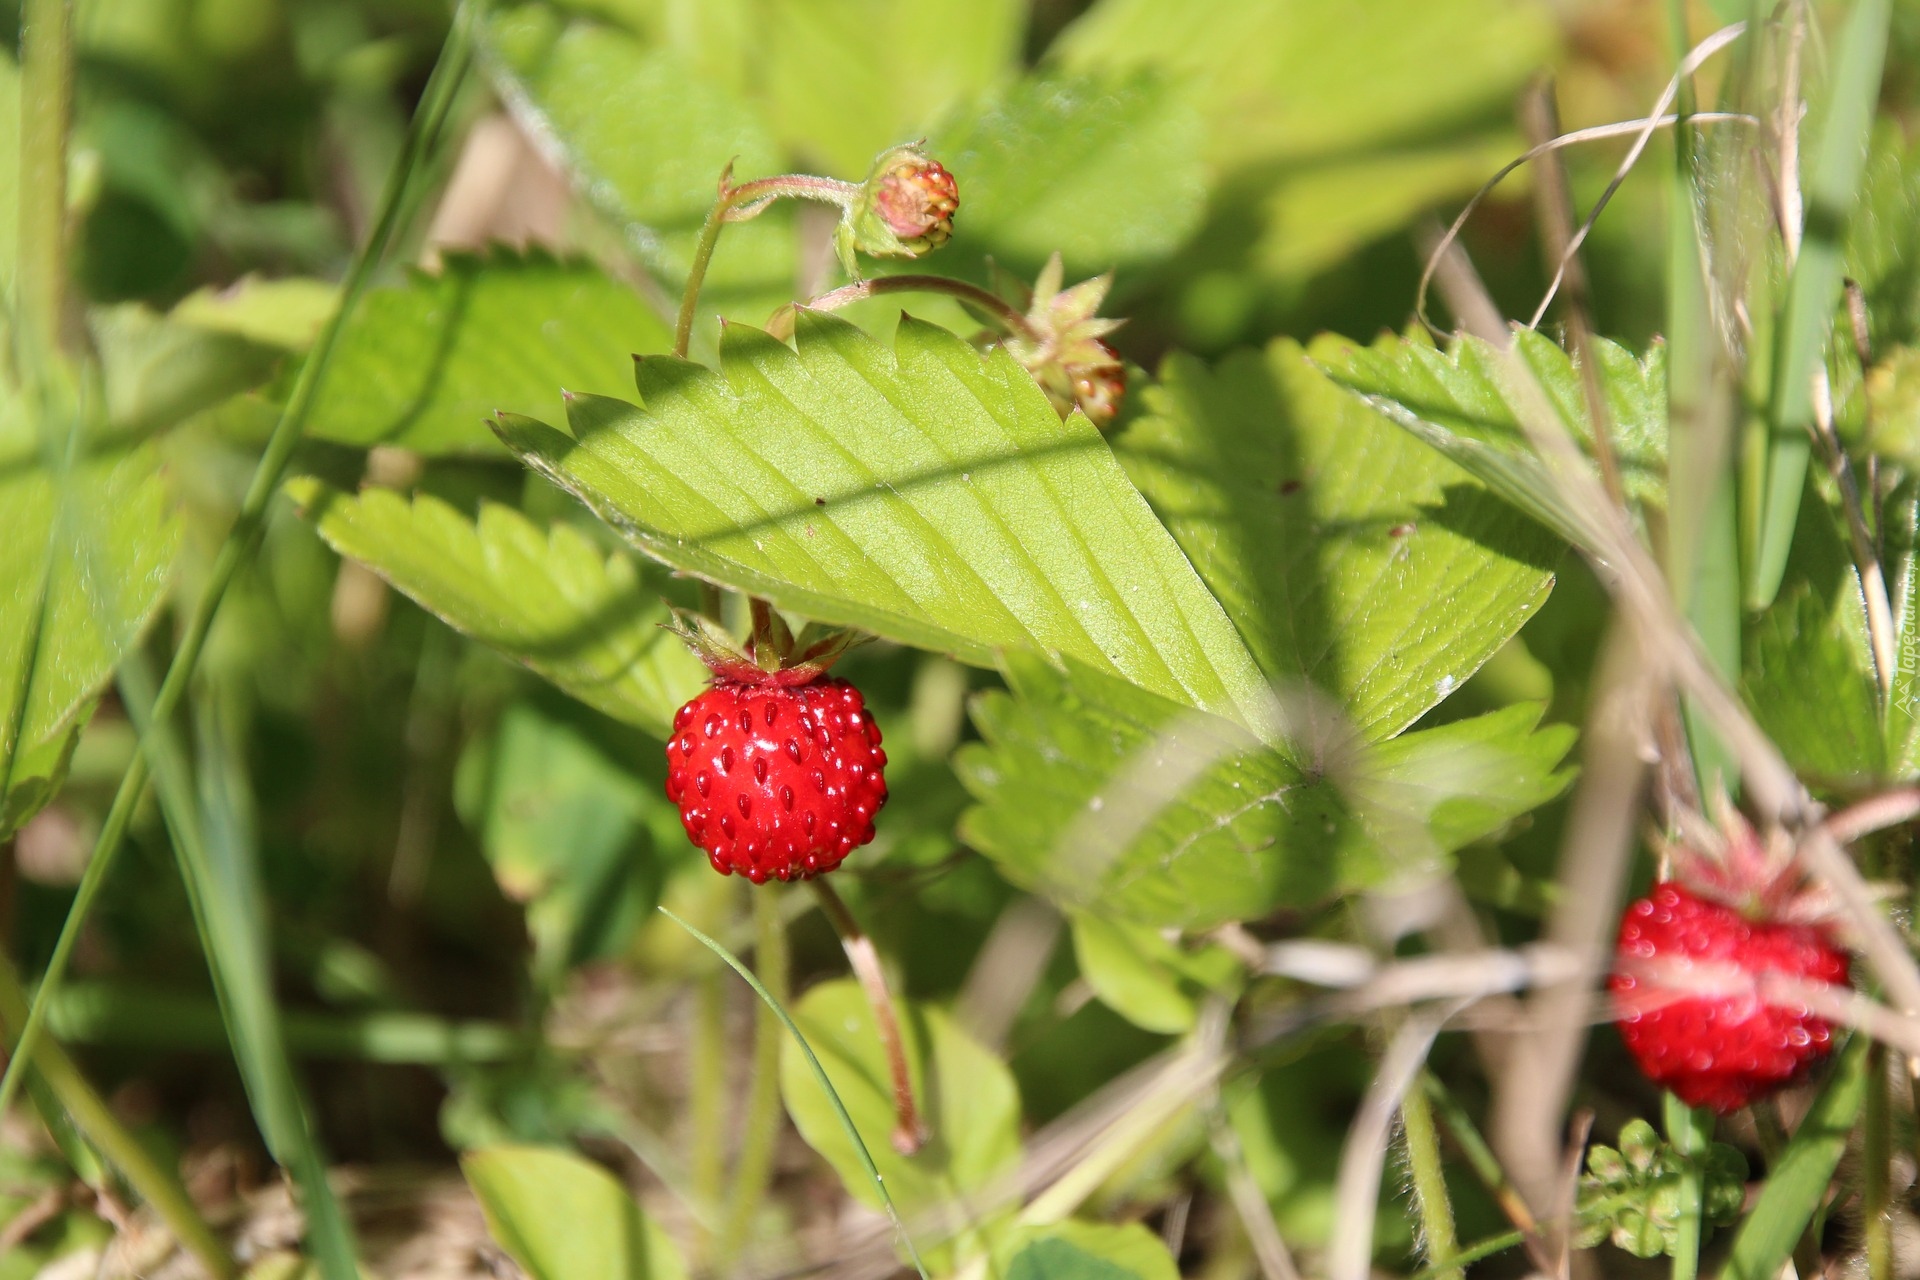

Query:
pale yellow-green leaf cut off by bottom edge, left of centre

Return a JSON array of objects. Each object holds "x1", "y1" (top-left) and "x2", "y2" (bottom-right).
[{"x1": 461, "y1": 1146, "x2": 687, "y2": 1280}]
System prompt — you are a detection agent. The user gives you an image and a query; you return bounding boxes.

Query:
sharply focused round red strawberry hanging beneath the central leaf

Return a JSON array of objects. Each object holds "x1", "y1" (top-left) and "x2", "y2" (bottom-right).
[{"x1": 666, "y1": 668, "x2": 887, "y2": 885}]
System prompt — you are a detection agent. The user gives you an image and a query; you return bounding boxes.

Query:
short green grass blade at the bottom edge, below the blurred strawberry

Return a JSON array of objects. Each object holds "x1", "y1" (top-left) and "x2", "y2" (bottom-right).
[{"x1": 1720, "y1": 1036, "x2": 1868, "y2": 1280}]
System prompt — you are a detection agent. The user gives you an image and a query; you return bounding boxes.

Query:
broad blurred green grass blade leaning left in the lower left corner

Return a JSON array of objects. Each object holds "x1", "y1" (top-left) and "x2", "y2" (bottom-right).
[{"x1": 121, "y1": 652, "x2": 359, "y2": 1280}]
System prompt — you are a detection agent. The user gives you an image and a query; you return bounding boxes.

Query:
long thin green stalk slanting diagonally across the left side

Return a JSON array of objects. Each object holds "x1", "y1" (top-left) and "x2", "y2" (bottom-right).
[{"x1": 0, "y1": 0, "x2": 476, "y2": 1115}]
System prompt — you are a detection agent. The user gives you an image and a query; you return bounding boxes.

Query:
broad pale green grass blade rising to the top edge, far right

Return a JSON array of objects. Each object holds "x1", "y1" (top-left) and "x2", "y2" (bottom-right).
[{"x1": 1747, "y1": 0, "x2": 1891, "y2": 608}]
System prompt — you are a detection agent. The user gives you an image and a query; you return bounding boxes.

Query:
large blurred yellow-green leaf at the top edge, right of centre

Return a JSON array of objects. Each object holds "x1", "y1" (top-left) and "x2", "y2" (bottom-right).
[{"x1": 1056, "y1": 0, "x2": 1557, "y2": 163}]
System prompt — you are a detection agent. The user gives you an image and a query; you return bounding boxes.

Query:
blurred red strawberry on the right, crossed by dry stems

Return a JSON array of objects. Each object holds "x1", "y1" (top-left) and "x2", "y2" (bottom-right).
[{"x1": 1609, "y1": 882, "x2": 1849, "y2": 1115}]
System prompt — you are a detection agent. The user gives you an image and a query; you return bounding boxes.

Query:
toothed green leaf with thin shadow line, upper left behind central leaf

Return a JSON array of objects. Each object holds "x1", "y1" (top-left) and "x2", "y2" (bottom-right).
[{"x1": 307, "y1": 251, "x2": 672, "y2": 453}]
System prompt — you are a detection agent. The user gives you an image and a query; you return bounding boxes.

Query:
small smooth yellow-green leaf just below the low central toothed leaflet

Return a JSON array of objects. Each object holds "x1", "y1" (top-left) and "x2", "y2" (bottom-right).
[{"x1": 1071, "y1": 913, "x2": 1240, "y2": 1036}]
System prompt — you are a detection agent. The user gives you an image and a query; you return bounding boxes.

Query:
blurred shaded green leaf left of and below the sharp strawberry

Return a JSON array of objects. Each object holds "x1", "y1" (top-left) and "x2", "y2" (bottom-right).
[{"x1": 463, "y1": 702, "x2": 660, "y2": 984}]
